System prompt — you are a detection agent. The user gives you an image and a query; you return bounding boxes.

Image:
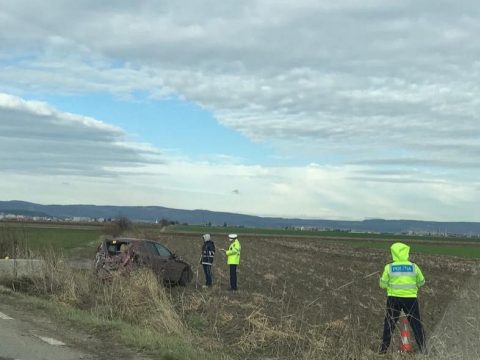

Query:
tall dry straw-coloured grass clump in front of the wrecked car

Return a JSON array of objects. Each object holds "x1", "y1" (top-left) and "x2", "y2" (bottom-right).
[{"x1": 24, "y1": 252, "x2": 186, "y2": 336}]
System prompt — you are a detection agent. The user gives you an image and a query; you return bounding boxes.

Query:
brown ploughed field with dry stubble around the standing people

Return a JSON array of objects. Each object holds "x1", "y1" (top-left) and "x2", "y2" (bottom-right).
[{"x1": 145, "y1": 233, "x2": 478, "y2": 359}]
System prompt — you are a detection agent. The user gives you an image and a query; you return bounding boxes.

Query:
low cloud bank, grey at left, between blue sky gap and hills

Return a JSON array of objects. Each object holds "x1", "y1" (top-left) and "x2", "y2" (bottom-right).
[{"x1": 0, "y1": 94, "x2": 480, "y2": 220}]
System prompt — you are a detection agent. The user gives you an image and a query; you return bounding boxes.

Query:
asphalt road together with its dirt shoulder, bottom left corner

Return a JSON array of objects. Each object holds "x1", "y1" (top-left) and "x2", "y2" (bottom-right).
[{"x1": 0, "y1": 287, "x2": 149, "y2": 360}]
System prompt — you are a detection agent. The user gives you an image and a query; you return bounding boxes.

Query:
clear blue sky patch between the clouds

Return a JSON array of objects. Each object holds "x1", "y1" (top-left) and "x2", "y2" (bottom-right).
[{"x1": 36, "y1": 93, "x2": 278, "y2": 164}]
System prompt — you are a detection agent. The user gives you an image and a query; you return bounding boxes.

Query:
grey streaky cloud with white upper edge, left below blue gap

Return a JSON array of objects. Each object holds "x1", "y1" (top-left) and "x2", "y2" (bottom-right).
[{"x1": 0, "y1": 93, "x2": 161, "y2": 176}]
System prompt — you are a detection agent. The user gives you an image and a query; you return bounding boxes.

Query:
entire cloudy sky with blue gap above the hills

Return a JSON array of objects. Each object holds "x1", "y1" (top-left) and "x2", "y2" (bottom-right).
[{"x1": 0, "y1": 0, "x2": 480, "y2": 221}]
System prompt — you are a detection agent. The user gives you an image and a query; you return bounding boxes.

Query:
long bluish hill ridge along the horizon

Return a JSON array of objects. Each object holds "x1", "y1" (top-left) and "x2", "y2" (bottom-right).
[{"x1": 0, "y1": 201, "x2": 480, "y2": 235}]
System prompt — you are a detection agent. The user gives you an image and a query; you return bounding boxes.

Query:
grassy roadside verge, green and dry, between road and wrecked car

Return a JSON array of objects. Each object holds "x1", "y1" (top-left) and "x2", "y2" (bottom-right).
[{"x1": 3, "y1": 253, "x2": 221, "y2": 360}]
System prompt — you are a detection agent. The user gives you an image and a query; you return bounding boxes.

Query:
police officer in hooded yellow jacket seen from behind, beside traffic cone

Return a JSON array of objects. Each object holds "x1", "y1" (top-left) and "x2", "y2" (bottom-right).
[{"x1": 380, "y1": 242, "x2": 426, "y2": 354}]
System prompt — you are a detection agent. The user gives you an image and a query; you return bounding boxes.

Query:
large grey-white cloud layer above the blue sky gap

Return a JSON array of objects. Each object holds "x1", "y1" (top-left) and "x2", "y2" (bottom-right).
[{"x1": 0, "y1": 0, "x2": 480, "y2": 174}]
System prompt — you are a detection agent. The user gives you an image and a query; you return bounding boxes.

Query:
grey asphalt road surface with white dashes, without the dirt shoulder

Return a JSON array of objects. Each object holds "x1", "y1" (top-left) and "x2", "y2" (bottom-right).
[{"x1": 0, "y1": 305, "x2": 94, "y2": 360}]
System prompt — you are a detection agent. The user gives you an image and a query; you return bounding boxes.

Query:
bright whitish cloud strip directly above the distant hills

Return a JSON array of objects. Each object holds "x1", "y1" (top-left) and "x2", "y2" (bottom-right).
[{"x1": 0, "y1": 161, "x2": 480, "y2": 221}]
